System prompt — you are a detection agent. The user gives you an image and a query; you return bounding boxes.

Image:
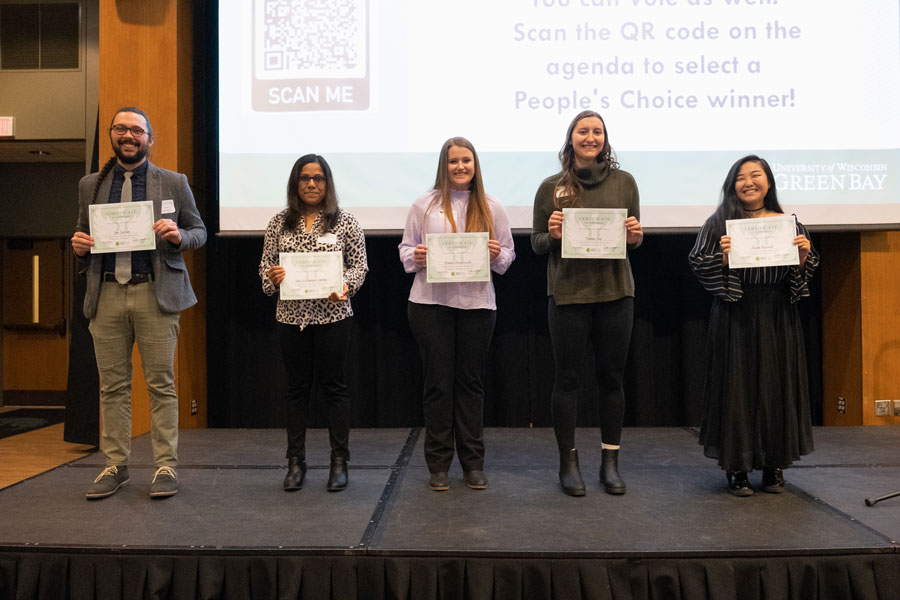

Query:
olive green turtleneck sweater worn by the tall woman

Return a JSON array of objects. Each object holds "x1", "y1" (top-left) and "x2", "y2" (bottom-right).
[{"x1": 531, "y1": 162, "x2": 641, "y2": 304}]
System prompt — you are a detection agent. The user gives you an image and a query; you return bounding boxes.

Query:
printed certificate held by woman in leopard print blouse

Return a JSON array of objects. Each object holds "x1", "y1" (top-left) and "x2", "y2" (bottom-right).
[{"x1": 278, "y1": 252, "x2": 344, "y2": 300}]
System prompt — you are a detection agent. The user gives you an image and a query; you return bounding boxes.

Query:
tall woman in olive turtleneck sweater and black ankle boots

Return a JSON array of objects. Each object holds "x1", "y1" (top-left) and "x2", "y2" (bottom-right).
[{"x1": 531, "y1": 111, "x2": 643, "y2": 496}]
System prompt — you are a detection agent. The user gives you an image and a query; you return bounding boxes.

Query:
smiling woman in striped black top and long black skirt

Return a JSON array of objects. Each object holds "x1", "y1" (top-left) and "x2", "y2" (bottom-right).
[{"x1": 689, "y1": 155, "x2": 819, "y2": 496}]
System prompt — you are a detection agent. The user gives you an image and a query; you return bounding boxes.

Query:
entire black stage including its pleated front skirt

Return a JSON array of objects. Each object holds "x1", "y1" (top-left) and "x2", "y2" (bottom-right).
[{"x1": 0, "y1": 427, "x2": 900, "y2": 600}]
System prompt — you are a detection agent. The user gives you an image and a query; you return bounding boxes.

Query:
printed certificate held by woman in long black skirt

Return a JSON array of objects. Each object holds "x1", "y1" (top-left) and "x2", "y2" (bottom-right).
[{"x1": 725, "y1": 215, "x2": 800, "y2": 269}]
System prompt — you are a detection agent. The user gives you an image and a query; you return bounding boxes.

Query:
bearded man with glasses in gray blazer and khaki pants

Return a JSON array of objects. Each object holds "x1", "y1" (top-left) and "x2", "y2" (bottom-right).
[{"x1": 72, "y1": 107, "x2": 206, "y2": 499}]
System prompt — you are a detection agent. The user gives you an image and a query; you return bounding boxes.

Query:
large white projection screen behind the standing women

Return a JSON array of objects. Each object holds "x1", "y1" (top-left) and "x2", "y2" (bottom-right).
[{"x1": 219, "y1": 0, "x2": 900, "y2": 233}]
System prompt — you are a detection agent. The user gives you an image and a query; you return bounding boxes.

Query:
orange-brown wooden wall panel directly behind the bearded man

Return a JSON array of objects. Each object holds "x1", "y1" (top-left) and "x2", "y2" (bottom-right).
[{"x1": 100, "y1": 0, "x2": 206, "y2": 435}]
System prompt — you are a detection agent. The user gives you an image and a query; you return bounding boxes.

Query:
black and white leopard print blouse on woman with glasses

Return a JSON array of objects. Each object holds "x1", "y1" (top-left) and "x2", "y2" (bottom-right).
[{"x1": 259, "y1": 209, "x2": 369, "y2": 329}]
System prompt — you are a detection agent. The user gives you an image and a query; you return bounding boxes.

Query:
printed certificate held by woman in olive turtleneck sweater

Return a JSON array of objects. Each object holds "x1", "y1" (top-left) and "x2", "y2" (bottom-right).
[{"x1": 562, "y1": 208, "x2": 628, "y2": 259}]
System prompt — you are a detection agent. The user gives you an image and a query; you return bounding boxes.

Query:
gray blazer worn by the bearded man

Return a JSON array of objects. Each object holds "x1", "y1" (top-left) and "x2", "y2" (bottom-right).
[{"x1": 76, "y1": 161, "x2": 206, "y2": 319}]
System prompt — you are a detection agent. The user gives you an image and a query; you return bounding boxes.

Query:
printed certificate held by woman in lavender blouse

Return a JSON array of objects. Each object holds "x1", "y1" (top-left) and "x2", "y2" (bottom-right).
[{"x1": 425, "y1": 231, "x2": 491, "y2": 283}]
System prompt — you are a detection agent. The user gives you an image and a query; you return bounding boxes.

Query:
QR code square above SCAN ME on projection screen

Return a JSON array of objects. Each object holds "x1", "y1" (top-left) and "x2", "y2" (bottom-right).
[{"x1": 254, "y1": 0, "x2": 367, "y2": 79}]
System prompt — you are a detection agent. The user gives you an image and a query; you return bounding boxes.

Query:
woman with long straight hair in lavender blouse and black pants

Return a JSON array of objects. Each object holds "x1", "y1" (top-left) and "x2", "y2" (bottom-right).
[{"x1": 399, "y1": 137, "x2": 516, "y2": 491}]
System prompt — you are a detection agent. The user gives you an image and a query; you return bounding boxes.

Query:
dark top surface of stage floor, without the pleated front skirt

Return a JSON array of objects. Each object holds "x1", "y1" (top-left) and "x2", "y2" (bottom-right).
[{"x1": 0, "y1": 427, "x2": 900, "y2": 558}]
